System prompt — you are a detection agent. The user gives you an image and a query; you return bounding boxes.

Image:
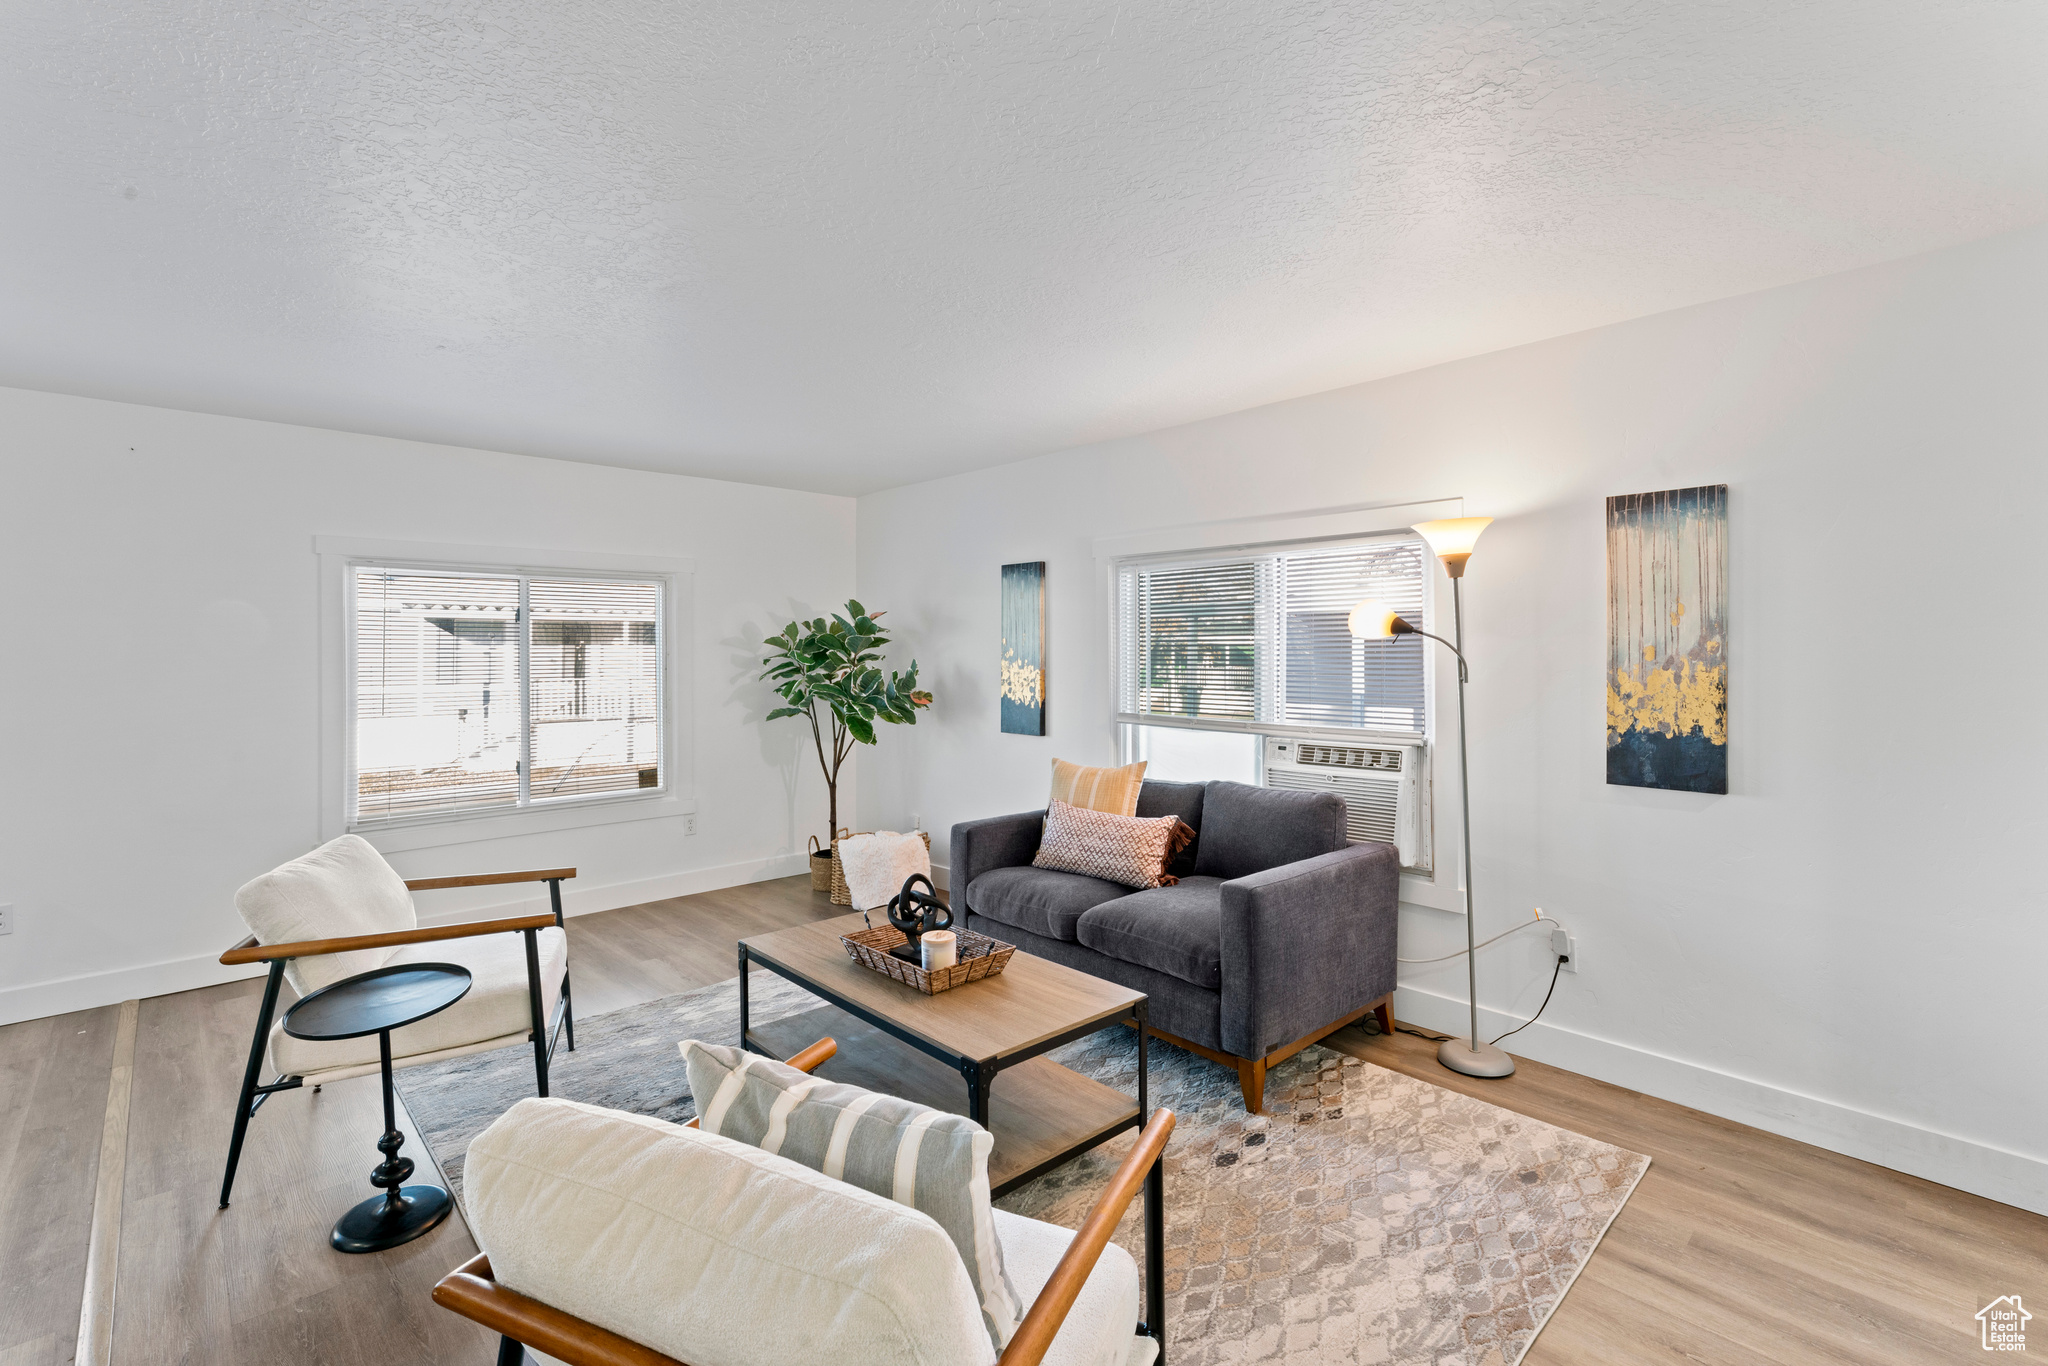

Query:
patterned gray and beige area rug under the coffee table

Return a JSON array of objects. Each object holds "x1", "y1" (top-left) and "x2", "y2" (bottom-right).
[{"x1": 395, "y1": 973, "x2": 1649, "y2": 1366}]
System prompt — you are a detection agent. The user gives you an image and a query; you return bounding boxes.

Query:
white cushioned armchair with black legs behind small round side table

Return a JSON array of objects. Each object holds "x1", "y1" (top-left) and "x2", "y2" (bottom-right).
[{"x1": 221, "y1": 836, "x2": 575, "y2": 1206}]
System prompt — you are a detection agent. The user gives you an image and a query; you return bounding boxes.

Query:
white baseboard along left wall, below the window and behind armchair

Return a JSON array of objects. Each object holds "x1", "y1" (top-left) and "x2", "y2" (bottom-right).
[{"x1": 0, "y1": 854, "x2": 805, "y2": 1024}]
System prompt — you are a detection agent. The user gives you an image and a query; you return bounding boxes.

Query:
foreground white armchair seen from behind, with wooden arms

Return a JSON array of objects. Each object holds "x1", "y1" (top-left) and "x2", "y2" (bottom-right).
[{"x1": 434, "y1": 1038, "x2": 1174, "y2": 1366}]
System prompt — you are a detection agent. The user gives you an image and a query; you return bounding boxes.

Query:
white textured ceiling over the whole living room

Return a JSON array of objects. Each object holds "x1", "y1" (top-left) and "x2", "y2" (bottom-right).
[{"x1": 0, "y1": 0, "x2": 2048, "y2": 492}]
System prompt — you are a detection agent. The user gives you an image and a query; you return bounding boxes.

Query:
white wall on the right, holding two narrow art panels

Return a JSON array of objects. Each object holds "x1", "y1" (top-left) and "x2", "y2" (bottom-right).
[{"x1": 858, "y1": 231, "x2": 2048, "y2": 1212}]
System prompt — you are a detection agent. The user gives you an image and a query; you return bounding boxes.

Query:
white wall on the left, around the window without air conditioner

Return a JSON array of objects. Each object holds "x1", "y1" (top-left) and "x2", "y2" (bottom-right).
[{"x1": 0, "y1": 389, "x2": 854, "y2": 1022}]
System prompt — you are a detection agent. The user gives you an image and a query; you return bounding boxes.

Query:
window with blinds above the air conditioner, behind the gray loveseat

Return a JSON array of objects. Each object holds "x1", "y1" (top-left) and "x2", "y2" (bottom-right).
[{"x1": 1118, "y1": 539, "x2": 1430, "y2": 733}]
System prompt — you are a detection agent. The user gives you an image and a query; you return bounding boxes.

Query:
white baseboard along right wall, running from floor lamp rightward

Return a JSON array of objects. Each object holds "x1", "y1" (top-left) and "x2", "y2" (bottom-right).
[{"x1": 1395, "y1": 987, "x2": 2048, "y2": 1214}]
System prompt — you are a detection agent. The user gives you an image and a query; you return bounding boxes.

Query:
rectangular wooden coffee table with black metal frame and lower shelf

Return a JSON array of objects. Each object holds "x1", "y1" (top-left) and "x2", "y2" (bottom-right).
[{"x1": 739, "y1": 913, "x2": 1151, "y2": 1196}]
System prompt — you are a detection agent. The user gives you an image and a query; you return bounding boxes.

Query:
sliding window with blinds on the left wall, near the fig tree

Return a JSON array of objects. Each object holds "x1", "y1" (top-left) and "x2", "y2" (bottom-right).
[{"x1": 348, "y1": 565, "x2": 664, "y2": 825}]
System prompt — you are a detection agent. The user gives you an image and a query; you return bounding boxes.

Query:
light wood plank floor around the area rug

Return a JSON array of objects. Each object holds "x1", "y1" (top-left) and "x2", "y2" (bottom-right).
[{"x1": 0, "y1": 879, "x2": 2048, "y2": 1366}]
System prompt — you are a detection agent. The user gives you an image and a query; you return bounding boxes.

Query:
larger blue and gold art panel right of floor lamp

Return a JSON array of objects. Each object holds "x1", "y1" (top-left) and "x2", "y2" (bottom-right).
[{"x1": 1608, "y1": 483, "x2": 1729, "y2": 793}]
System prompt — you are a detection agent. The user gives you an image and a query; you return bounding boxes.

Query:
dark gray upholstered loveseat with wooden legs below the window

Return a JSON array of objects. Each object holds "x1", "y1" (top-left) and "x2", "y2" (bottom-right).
[{"x1": 950, "y1": 782, "x2": 1401, "y2": 1114}]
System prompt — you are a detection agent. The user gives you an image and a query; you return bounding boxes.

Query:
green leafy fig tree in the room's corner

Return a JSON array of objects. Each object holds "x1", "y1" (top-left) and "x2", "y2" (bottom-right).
[{"x1": 762, "y1": 598, "x2": 932, "y2": 850}]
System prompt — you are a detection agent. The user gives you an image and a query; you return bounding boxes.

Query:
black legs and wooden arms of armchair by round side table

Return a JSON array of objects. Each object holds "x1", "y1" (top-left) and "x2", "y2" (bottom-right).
[{"x1": 221, "y1": 868, "x2": 575, "y2": 1208}]
